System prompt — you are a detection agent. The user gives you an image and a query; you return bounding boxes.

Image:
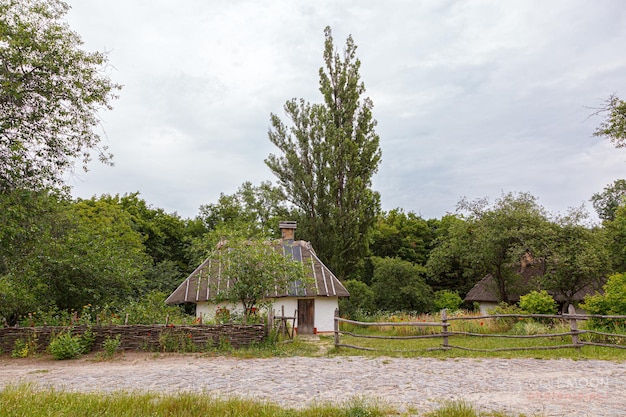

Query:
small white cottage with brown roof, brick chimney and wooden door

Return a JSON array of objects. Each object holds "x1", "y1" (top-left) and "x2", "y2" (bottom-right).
[{"x1": 165, "y1": 222, "x2": 350, "y2": 334}]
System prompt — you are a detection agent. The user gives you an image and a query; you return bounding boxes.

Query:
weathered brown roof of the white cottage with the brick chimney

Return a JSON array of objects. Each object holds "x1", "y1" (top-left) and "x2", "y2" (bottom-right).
[{"x1": 165, "y1": 239, "x2": 350, "y2": 304}]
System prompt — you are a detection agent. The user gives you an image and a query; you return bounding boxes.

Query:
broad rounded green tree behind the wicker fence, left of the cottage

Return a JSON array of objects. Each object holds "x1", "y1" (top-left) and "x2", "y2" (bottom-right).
[{"x1": 37, "y1": 199, "x2": 149, "y2": 310}]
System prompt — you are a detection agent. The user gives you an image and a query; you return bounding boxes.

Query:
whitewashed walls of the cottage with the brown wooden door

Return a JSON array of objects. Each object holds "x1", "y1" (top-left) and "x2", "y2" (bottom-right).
[{"x1": 196, "y1": 297, "x2": 339, "y2": 333}]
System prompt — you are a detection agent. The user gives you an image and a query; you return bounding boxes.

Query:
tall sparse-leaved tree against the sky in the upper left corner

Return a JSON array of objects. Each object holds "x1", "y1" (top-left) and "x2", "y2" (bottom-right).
[{"x1": 0, "y1": 0, "x2": 120, "y2": 190}]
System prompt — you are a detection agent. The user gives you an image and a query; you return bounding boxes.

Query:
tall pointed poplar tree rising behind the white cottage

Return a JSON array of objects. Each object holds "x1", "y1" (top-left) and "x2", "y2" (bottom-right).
[{"x1": 265, "y1": 27, "x2": 381, "y2": 278}]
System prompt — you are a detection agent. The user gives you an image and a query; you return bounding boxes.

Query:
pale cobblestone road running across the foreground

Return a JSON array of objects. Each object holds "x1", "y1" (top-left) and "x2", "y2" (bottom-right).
[{"x1": 0, "y1": 353, "x2": 626, "y2": 416}]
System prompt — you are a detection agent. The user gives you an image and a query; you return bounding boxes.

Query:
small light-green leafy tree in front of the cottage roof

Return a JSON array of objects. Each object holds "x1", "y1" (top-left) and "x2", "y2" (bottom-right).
[{"x1": 210, "y1": 239, "x2": 309, "y2": 318}]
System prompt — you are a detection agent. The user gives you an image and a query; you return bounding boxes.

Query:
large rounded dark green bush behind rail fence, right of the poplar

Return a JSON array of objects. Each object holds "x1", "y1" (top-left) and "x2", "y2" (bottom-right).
[{"x1": 372, "y1": 257, "x2": 433, "y2": 312}]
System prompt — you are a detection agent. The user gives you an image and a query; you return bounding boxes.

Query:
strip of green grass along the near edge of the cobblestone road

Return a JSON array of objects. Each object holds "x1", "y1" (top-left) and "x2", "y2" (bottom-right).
[{"x1": 0, "y1": 385, "x2": 528, "y2": 417}]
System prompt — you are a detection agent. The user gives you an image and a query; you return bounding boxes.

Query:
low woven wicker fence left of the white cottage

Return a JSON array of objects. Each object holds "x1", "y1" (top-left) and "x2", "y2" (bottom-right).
[{"x1": 0, "y1": 324, "x2": 267, "y2": 352}]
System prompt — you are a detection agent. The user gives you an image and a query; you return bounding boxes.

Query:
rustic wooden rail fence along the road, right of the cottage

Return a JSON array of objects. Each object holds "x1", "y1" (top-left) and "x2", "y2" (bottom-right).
[{"x1": 334, "y1": 305, "x2": 626, "y2": 352}]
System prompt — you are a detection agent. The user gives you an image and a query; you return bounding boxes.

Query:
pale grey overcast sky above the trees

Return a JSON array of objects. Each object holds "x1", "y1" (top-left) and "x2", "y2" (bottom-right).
[{"x1": 67, "y1": 0, "x2": 626, "y2": 218}]
